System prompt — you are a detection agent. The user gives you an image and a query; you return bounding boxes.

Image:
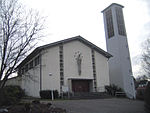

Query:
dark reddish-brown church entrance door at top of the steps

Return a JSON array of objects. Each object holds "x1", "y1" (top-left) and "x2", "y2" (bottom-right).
[{"x1": 72, "y1": 80, "x2": 90, "y2": 92}]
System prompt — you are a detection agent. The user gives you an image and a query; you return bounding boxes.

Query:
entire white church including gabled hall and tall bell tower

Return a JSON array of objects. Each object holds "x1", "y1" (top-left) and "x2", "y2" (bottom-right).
[{"x1": 6, "y1": 3, "x2": 135, "y2": 98}]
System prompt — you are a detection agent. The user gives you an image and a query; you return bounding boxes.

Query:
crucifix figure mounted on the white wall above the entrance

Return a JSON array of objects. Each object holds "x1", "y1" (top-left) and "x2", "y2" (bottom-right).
[{"x1": 74, "y1": 51, "x2": 83, "y2": 75}]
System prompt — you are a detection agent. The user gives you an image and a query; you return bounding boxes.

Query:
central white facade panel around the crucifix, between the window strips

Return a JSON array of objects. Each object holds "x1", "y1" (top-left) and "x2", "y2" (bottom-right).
[{"x1": 64, "y1": 41, "x2": 93, "y2": 85}]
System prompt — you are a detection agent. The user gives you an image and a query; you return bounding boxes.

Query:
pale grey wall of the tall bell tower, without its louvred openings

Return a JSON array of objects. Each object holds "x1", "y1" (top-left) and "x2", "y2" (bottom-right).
[{"x1": 104, "y1": 5, "x2": 135, "y2": 97}]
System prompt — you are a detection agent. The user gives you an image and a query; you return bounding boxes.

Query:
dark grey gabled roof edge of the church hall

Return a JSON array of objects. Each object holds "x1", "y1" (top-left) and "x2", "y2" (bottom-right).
[{"x1": 18, "y1": 36, "x2": 112, "y2": 67}]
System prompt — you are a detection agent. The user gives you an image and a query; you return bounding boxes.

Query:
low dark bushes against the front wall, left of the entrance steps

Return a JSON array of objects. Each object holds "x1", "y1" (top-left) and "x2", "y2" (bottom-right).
[{"x1": 40, "y1": 90, "x2": 59, "y2": 99}]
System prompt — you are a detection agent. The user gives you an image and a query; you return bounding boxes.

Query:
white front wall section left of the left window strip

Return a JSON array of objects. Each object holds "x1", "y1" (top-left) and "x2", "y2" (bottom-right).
[{"x1": 42, "y1": 46, "x2": 60, "y2": 91}]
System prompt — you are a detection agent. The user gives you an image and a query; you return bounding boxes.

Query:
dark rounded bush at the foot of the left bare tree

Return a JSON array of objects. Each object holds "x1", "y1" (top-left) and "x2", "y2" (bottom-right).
[{"x1": 0, "y1": 86, "x2": 25, "y2": 105}]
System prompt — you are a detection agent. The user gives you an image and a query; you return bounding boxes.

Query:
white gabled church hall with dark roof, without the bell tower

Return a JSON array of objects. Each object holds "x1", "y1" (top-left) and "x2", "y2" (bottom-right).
[{"x1": 14, "y1": 36, "x2": 112, "y2": 97}]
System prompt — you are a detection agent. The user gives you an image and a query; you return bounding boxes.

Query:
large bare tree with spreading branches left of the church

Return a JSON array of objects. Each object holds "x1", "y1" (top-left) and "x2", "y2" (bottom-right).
[{"x1": 0, "y1": 0, "x2": 44, "y2": 89}]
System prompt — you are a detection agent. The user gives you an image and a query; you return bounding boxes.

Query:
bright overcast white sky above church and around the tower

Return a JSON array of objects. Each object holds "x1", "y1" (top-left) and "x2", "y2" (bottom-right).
[{"x1": 21, "y1": 0, "x2": 150, "y2": 77}]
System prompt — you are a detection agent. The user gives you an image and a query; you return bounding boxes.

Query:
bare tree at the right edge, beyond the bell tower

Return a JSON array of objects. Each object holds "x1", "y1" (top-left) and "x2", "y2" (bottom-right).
[{"x1": 142, "y1": 38, "x2": 150, "y2": 78}]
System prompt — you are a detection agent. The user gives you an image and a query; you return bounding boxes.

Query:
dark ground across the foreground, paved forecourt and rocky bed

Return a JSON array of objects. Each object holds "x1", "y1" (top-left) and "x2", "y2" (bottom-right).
[{"x1": 0, "y1": 98, "x2": 146, "y2": 113}]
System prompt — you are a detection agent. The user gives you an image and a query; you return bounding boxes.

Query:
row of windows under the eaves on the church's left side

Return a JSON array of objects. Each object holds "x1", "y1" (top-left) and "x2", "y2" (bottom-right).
[{"x1": 20, "y1": 56, "x2": 40, "y2": 74}]
